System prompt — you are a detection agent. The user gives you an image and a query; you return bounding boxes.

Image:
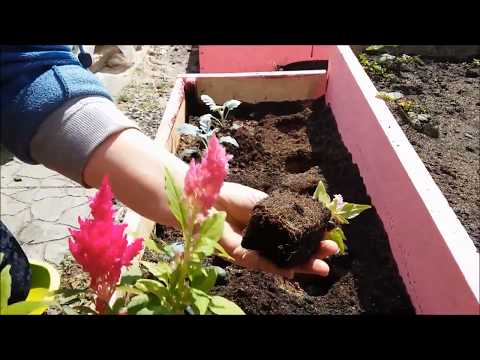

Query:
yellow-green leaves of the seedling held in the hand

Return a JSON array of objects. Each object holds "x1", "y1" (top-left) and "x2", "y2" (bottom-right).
[{"x1": 313, "y1": 181, "x2": 371, "y2": 255}]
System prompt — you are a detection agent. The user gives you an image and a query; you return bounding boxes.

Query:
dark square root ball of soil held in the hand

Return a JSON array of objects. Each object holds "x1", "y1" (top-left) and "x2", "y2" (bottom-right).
[{"x1": 242, "y1": 190, "x2": 330, "y2": 267}]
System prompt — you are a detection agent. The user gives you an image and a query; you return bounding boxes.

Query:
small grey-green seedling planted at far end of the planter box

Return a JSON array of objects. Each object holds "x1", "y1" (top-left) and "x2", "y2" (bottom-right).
[{"x1": 177, "y1": 95, "x2": 241, "y2": 158}]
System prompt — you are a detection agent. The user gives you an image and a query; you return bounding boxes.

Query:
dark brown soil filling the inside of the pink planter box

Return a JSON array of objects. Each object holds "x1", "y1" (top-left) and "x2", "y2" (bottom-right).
[{"x1": 165, "y1": 98, "x2": 413, "y2": 314}]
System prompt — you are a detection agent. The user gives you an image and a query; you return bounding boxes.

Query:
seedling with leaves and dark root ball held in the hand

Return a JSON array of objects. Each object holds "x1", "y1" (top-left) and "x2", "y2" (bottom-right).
[{"x1": 242, "y1": 181, "x2": 371, "y2": 267}]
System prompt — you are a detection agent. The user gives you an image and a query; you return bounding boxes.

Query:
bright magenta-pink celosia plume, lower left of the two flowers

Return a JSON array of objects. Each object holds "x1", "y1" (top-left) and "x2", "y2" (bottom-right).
[{"x1": 68, "y1": 176, "x2": 143, "y2": 313}]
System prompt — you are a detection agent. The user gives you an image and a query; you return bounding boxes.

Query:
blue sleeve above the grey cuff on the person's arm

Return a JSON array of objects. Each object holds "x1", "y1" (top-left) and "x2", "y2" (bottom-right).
[{"x1": 0, "y1": 45, "x2": 111, "y2": 164}]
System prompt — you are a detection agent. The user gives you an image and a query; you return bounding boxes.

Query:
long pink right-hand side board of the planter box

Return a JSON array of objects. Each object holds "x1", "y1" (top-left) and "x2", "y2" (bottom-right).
[{"x1": 326, "y1": 46, "x2": 480, "y2": 314}]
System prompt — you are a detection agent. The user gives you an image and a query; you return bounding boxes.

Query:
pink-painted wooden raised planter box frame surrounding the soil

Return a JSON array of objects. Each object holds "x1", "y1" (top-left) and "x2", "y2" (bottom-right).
[{"x1": 125, "y1": 46, "x2": 480, "y2": 314}]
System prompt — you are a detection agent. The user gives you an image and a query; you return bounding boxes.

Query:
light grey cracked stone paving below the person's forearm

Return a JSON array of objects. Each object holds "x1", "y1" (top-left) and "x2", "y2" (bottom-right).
[{"x1": 0, "y1": 159, "x2": 96, "y2": 265}]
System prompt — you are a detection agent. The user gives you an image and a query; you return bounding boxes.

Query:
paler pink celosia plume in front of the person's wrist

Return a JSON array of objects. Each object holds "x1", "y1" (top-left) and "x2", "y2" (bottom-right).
[{"x1": 185, "y1": 135, "x2": 232, "y2": 214}]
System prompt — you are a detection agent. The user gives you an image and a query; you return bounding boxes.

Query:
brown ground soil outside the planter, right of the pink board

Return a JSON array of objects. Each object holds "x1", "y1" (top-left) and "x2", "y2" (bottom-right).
[{"x1": 366, "y1": 55, "x2": 480, "y2": 250}]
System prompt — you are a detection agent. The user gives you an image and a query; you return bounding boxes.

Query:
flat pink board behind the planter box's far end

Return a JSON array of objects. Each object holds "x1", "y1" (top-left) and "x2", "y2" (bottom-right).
[{"x1": 199, "y1": 45, "x2": 313, "y2": 73}]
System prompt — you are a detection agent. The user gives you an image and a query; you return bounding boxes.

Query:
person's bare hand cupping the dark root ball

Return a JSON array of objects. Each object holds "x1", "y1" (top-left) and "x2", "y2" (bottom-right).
[{"x1": 215, "y1": 182, "x2": 338, "y2": 278}]
